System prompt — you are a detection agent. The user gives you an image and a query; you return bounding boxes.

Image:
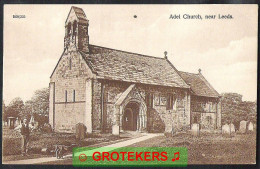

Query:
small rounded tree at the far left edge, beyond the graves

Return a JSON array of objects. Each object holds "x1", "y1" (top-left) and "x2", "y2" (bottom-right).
[{"x1": 4, "y1": 97, "x2": 24, "y2": 120}]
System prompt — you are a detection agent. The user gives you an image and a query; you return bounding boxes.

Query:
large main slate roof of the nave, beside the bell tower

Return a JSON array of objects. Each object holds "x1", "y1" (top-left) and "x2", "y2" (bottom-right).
[{"x1": 81, "y1": 45, "x2": 190, "y2": 88}]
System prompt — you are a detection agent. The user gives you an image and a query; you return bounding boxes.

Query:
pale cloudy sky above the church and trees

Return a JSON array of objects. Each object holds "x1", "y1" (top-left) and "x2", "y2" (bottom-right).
[{"x1": 3, "y1": 5, "x2": 258, "y2": 104}]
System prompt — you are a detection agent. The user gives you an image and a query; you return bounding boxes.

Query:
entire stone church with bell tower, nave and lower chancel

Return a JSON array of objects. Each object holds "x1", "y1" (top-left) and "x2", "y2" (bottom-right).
[{"x1": 49, "y1": 7, "x2": 221, "y2": 135}]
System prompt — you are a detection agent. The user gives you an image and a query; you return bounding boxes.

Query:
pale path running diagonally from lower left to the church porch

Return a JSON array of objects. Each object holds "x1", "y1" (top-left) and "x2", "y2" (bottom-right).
[{"x1": 3, "y1": 133, "x2": 158, "y2": 164}]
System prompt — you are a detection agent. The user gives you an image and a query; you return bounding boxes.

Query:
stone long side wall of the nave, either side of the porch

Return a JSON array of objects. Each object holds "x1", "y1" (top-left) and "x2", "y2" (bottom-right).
[{"x1": 98, "y1": 81, "x2": 190, "y2": 132}]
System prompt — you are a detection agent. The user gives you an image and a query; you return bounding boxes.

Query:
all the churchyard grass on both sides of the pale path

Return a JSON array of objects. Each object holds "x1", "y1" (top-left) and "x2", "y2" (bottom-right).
[{"x1": 3, "y1": 128, "x2": 256, "y2": 165}]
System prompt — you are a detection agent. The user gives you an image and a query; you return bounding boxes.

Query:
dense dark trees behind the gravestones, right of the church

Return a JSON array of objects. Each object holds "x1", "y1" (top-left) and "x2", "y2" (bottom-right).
[{"x1": 221, "y1": 93, "x2": 256, "y2": 128}]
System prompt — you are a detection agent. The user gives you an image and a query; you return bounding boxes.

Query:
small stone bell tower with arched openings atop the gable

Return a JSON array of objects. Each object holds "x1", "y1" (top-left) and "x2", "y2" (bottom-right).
[{"x1": 64, "y1": 6, "x2": 89, "y2": 53}]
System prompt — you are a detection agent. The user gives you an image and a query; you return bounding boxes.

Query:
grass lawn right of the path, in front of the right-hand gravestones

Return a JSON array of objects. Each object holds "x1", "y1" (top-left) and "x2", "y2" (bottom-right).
[{"x1": 130, "y1": 133, "x2": 256, "y2": 164}]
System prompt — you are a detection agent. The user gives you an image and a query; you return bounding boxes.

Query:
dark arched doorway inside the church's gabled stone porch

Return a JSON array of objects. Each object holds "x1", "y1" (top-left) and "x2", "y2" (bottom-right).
[{"x1": 122, "y1": 102, "x2": 140, "y2": 131}]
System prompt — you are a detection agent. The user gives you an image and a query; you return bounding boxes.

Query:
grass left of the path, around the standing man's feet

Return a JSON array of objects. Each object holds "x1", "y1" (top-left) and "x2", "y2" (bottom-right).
[{"x1": 2, "y1": 129, "x2": 124, "y2": 161}]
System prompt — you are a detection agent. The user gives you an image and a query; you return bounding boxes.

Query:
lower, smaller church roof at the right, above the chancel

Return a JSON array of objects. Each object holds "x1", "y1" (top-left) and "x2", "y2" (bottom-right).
[{"x1": 179, "y1": 71, "x2": 220, "y2": 97}]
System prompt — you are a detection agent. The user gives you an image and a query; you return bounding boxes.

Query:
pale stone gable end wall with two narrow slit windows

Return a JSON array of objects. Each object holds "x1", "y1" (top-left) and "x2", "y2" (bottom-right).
[{"x1": 50, "y1": 47, "x2": 92, "y2": 132}]
